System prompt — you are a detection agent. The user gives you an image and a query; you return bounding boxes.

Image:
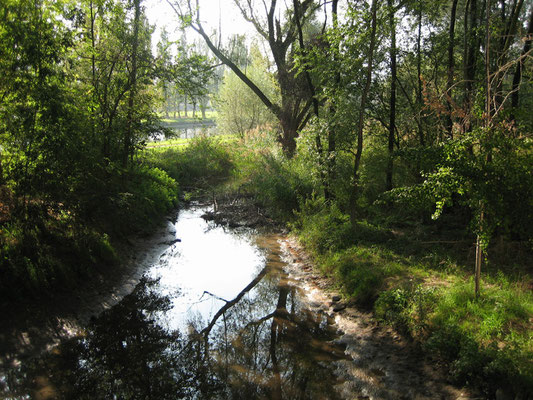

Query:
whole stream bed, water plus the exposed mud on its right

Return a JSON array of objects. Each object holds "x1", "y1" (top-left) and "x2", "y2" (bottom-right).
[{"x1": 0, "y1": 206, "x2": 474, "y2": 400}]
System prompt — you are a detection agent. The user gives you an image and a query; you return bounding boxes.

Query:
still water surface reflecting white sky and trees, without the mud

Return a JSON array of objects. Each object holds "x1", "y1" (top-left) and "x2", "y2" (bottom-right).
[{"x1": 4, "y1": 209, "x2": 344, "y2": 399}]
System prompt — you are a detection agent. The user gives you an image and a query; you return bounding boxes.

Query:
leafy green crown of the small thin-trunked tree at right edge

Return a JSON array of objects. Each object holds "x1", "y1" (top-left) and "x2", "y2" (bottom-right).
[{"x1": 388, "y1": 127, "x2": 533, "y2": 246}]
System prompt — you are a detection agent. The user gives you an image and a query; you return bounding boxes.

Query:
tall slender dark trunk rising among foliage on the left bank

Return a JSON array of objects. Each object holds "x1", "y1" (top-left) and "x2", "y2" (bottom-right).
[{"x1": 122, "y1": 0, "x2": 141, "y2": 167}]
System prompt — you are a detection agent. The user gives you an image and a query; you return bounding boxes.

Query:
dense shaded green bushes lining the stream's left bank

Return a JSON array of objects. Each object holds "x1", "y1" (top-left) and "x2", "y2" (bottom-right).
[{"x1": 0, "y1": 166, "x2": 178, "y2": 298}]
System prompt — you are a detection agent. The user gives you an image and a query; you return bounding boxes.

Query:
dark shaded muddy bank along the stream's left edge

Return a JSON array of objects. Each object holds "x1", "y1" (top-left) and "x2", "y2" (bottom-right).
[{"x1": 0, "y1": 211, "x2": 178, "y2": 382}]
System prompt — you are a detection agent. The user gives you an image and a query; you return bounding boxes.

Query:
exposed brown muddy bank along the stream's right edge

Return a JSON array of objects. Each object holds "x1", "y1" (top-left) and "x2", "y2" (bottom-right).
[{"x1": 282, "y1": 237, "x2": 483, "y2": 400}]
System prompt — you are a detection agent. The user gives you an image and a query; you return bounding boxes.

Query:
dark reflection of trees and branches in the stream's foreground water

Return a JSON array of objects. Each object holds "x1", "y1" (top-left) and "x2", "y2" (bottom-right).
[{"x1": 9, "y1": 262, "x2": 343, "y2": 400}]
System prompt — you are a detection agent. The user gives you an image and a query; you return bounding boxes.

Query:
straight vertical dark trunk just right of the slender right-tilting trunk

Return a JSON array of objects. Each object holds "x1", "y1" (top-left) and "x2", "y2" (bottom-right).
[{"x1": 385, "y1": 0, "x2": 396, "y2": 190}]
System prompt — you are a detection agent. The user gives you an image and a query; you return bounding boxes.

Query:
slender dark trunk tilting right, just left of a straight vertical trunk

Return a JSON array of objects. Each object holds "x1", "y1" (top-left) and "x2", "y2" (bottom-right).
[{"x1": 350, "y1": 0, "x2": 377, "y2": 228}]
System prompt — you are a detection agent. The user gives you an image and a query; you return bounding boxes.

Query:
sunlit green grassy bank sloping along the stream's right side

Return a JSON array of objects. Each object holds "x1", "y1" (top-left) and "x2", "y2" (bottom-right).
[{"x1": 293, "y1": 199, "x2": 533, "y2": 397}]
